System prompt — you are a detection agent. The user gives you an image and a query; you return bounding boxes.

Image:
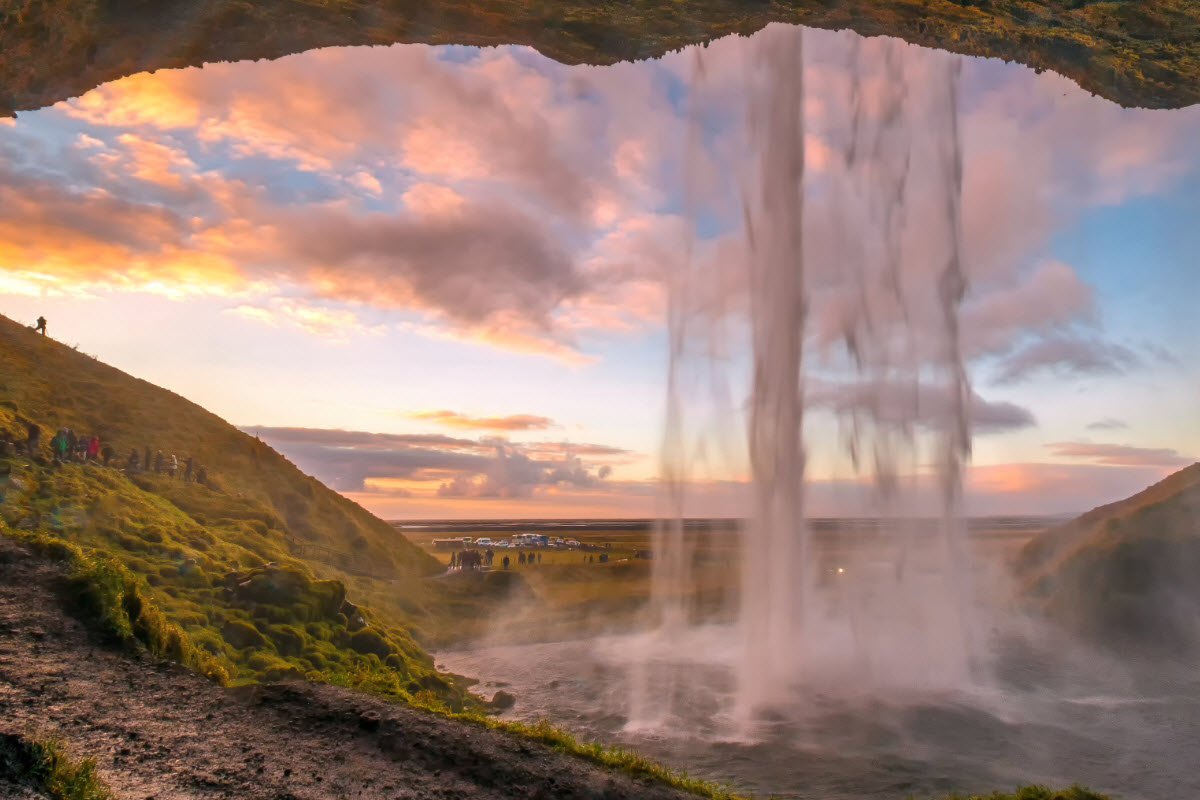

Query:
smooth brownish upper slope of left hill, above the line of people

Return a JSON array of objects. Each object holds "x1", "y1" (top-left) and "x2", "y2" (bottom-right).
[{"x1": 0, "y1": 317, "x2": 442, "y2": 578}]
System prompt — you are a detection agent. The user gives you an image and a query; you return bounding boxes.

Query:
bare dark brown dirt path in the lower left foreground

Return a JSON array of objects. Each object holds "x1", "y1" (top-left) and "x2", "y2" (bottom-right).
[{"x1": 0, "y1": 535, "x2": 692, "y2": 800}]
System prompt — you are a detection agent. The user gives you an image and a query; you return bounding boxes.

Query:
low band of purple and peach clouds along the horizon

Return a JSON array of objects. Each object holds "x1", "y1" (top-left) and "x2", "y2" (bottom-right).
[{"x1": 242, "y1": 427, "x2": 1195, "y2": 519}]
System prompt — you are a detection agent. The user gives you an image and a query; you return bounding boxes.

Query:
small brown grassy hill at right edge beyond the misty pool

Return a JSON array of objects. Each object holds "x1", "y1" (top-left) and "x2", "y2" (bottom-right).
[{"x1": 1018, "y1": 464, "x2": 1200, "y2": 651}]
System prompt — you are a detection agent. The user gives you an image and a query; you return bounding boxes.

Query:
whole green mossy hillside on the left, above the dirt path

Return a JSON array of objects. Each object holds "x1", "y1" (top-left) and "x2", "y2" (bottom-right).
[{"x1": 0, "y1": 309, "x2": 474, "y2": 706}]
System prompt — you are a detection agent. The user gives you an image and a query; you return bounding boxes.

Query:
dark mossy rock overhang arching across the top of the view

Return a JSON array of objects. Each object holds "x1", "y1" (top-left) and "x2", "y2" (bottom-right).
[{"x1": 0, "y1": 0, "x2": 1200, "y2": 115}]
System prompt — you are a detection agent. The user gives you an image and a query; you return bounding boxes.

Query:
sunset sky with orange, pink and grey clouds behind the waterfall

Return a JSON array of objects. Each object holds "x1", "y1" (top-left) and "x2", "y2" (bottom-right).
[{"x1": 0, "y1": 26, "x2": 1200, "y2": 519}]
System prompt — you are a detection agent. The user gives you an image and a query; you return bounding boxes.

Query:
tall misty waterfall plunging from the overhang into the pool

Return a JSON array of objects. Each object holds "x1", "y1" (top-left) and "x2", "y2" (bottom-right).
[{"x1": 635, "y1": 25, "x2": 979, "y2": 720}]
